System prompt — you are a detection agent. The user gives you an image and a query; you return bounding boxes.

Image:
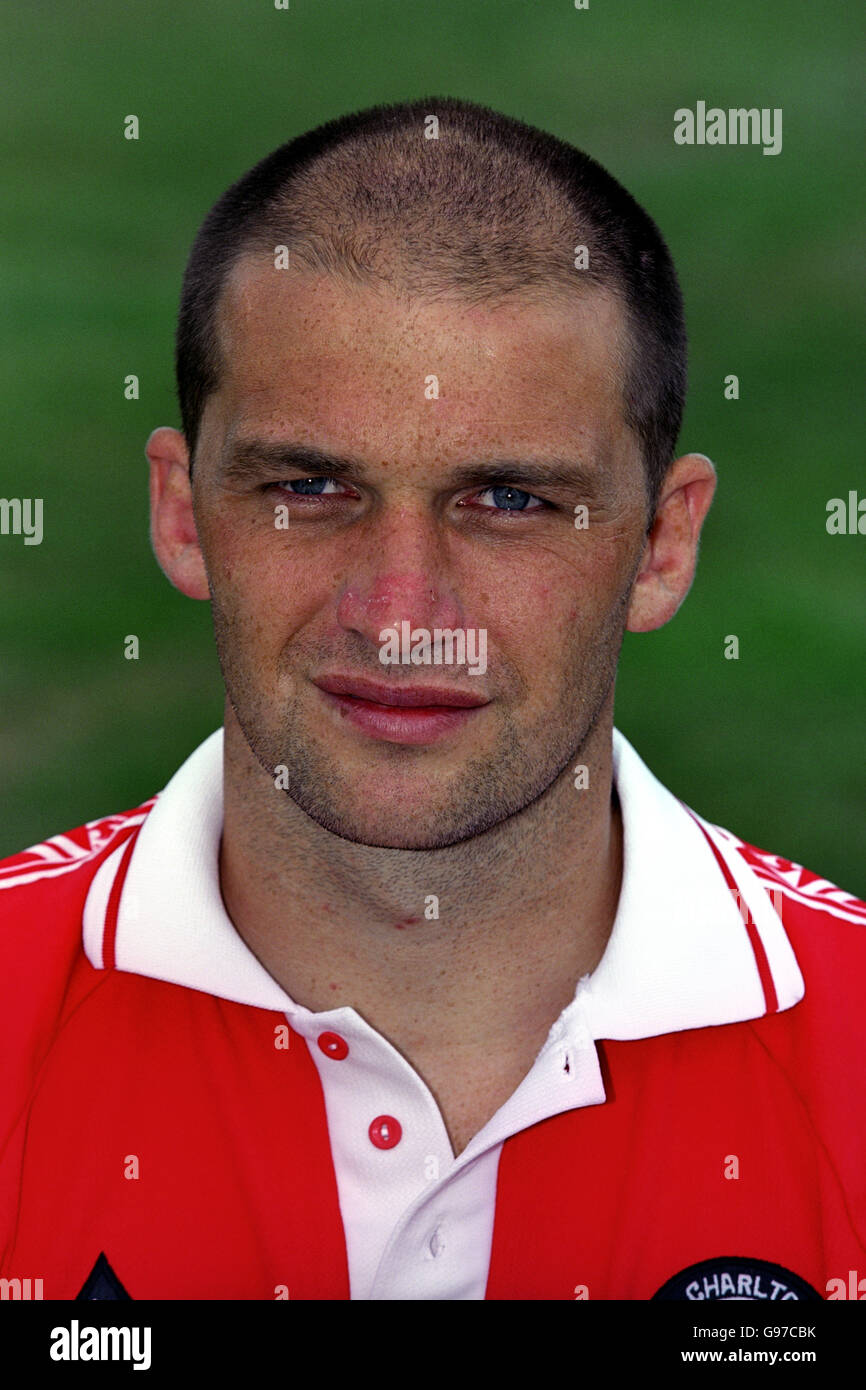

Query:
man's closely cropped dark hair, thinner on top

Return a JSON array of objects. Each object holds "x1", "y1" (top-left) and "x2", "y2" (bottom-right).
[{"x1": 175, "y1": 97, "x2": 687, "y2": 514}]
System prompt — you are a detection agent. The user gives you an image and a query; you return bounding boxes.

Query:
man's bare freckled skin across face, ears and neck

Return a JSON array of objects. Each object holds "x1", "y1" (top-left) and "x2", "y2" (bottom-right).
[{"x1": 147, "y1": 260, "x2": 714, "y2": 1152}]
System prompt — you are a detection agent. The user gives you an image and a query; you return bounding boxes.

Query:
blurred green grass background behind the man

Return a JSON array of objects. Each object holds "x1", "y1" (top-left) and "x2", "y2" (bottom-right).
[{"x1": 0, "y1": 0, "x2": 866, "y2": 895}]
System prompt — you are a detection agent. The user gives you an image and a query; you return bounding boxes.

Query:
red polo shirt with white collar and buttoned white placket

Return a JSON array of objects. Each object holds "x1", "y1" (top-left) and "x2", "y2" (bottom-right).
[{"x1": 0, "y1": 733, "x2": 866, "y2": 1301}]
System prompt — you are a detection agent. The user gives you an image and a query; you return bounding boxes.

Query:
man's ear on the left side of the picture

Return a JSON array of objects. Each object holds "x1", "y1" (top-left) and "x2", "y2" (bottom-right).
[{"x1": 145, "y1": 425, "x2": 210, "y2": 599}]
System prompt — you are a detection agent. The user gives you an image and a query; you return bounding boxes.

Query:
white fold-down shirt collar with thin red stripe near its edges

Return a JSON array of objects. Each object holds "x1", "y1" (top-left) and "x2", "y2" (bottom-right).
[{"x1": 83, "y1": 728, "x2": 805, "y2": 1038}]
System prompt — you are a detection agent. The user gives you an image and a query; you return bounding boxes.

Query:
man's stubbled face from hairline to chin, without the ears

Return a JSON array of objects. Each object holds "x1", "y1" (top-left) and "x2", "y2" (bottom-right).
[{"x1": 193, "y1": 259, "x2": 646, "y2": 849}]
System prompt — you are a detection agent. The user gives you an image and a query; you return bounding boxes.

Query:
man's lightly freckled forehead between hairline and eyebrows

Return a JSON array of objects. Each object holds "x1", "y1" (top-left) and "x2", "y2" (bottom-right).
[{"x1": 206, "y1": 256, "x2": 626, "y2": 464}]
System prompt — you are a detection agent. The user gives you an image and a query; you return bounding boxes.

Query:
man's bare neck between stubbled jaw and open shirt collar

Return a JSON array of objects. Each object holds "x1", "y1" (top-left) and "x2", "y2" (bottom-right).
[{"x1": 220, "y1": 708, "x2": 621, "y2": 1063}]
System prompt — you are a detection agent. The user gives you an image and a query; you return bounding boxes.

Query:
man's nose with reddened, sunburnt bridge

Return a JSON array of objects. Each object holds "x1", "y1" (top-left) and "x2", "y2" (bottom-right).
[{"x1": 336, "y1": 507, "x2": 464, "y2": 648}]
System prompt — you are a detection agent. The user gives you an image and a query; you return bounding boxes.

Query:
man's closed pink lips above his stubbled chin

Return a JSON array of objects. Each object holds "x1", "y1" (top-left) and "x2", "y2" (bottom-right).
[{"x1": 313, "y1": 676, "x2": 489, "y2": 744}]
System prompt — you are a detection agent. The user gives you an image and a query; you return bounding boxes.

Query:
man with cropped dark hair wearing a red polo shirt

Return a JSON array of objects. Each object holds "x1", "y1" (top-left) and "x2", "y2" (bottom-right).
[{"x1": 0, "y1": 99, "x2": 866, "y2": 1301}]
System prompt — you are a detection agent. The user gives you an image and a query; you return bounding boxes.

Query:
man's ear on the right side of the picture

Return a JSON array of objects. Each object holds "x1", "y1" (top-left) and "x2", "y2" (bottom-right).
[{"x1": 626, "y1": 453, "x2": 716, "y2": 632}]
